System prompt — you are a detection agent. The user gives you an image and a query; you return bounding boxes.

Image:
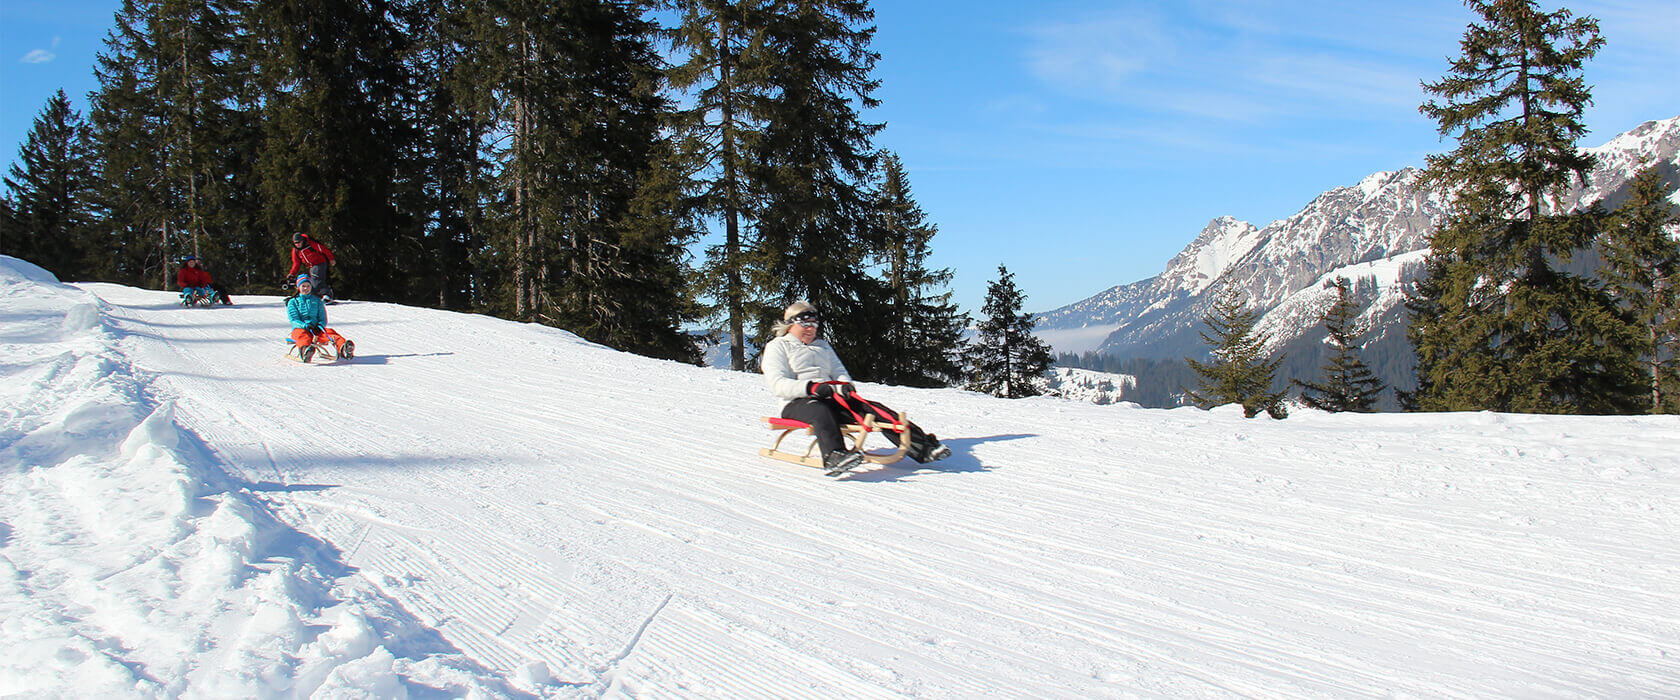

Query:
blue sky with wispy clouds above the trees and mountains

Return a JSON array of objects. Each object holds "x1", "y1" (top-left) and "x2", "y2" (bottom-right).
[{"x1": 0, "y1": 0, "x2": 1680, "y2": 311}]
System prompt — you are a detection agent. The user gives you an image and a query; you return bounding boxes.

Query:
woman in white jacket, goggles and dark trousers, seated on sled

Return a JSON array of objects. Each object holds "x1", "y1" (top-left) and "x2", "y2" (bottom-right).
[{"x1": 759, "y1": 300, "x2": 951, "y2": 475}]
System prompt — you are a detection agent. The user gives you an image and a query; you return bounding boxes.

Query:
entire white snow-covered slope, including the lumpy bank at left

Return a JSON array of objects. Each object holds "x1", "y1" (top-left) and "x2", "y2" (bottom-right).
[{"x1": 0, "y1": 257, "x2": 1680, "y2": 698}]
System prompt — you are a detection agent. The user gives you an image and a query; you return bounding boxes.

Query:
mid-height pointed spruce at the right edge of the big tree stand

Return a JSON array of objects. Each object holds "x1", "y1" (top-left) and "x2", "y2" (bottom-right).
[{"x1": 874, "y1": 153, "x2": 968, "y2": 386}]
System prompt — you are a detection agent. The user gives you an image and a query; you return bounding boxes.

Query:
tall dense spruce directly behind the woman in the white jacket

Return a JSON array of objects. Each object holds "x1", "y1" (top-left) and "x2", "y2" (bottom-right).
[{"x1": 748, "y1": 0, "x2": 887, "y2": 359}]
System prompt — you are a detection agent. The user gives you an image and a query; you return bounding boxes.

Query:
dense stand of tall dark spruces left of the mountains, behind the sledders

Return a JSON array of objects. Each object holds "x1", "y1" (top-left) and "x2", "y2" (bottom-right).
[{"x1": 0, "y1": 0, "x2": 966, "y2": 386}]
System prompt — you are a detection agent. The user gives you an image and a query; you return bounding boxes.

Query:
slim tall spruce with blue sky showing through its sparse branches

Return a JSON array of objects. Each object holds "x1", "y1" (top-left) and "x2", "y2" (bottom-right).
[{"x1": 669, "y1": 0, "x2": 773, "y2": 371}]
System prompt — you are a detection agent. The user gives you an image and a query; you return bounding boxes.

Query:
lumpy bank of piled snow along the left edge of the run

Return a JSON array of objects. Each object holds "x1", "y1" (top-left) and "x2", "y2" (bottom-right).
[{"x1": 0, "y1": 257, "x2": 510, "y2": 698}]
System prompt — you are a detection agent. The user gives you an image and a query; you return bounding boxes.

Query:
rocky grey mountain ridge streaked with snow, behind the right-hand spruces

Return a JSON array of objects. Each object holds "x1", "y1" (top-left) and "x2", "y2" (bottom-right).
[{"x1": 1038, "y1": 118, "x2": 1680, "y2": 387}]
